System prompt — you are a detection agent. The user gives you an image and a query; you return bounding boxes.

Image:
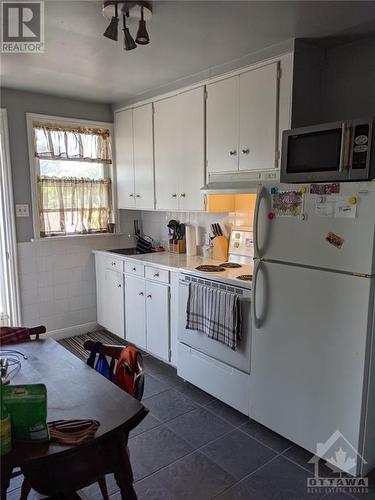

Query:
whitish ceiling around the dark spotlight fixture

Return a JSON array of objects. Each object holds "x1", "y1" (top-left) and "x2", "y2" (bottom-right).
[{"x1": 1, "y1": 0, "x2": 375, "y2": 103}]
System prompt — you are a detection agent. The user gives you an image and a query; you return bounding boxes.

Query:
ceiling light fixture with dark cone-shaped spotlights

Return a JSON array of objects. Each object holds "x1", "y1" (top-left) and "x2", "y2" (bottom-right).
[{"x1": 103, "y1": 0, "x2": 152, "y2": 50}]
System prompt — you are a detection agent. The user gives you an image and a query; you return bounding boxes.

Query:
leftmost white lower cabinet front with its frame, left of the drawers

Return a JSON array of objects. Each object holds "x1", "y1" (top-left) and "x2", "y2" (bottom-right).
[{"x1": 96, "y1": 265, "x2": 125, "y2": 338}]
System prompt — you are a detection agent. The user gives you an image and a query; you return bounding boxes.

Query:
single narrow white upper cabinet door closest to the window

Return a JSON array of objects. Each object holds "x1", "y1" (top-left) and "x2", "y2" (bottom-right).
[{"x1": 115, "y1": 109, "x2": 135, "y2": 208}]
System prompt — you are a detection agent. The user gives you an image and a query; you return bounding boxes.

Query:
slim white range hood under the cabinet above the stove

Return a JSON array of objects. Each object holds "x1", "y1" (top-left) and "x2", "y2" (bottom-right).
[{"x1": 201, "y1": 170, "x2": 280, "y2": 194}]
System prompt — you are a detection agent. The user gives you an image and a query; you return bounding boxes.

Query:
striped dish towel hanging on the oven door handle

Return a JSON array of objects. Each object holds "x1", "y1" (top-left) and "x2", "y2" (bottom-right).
[{"x1": 186, "y1": 283, "x2": 241, "y2": 351}]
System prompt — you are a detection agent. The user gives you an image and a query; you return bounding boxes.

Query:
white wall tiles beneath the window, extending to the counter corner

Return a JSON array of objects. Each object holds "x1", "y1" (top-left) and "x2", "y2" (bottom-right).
[{"x1": 17, "y1": 211, "x2": 139, "y2": 331}]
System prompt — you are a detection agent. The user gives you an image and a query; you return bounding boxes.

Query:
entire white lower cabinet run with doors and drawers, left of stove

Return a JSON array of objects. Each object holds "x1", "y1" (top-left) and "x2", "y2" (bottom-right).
[{"x1": 95, "y1": 252, "x2": 173, "y2": 364}]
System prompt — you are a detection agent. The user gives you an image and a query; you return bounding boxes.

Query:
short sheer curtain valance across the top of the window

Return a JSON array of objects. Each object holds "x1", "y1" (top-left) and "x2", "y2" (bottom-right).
[{"x1": 33, "y1": 122, "x2": 112, "y2": 163}]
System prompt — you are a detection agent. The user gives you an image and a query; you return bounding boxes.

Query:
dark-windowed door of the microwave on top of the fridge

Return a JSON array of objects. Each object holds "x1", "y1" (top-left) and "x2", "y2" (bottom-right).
[{"x1": 280, "y1": 122, "x2": 351, "y2": 183}]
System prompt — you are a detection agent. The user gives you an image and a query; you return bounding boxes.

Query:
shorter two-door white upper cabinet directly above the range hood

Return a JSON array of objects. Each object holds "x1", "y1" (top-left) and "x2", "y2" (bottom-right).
[{"x1": 207, "y1": 62, "x2": 279, "y2": 173}]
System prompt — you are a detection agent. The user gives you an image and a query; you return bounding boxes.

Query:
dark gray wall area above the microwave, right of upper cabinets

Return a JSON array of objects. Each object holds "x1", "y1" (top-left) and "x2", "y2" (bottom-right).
[{"x1": 292, "y1": 37, "x2": 375, "y2": 127}]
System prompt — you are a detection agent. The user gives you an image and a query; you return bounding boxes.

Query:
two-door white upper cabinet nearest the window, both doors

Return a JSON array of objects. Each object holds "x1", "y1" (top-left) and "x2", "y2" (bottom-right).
[{"x1": 115, "y1": 104, "x2": 154, "y2": 209}]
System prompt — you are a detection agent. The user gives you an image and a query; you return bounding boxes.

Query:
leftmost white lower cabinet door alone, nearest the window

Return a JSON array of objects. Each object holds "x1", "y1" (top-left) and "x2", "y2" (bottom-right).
[{"x1": 101, "y1": 269, "x2": 125, "y2": 338}]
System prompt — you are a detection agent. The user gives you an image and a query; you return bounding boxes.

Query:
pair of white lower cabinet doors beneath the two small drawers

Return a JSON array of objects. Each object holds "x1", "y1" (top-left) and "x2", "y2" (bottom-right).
[{"x1": 125, "y1": 275, "x2": 169, "y2": 361}]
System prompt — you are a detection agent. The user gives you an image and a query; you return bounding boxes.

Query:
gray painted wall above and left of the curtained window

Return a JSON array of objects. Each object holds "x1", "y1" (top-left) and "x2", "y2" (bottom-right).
[{"x1": 0, "y1": 88, "x2": 113, "y2": 242}]
